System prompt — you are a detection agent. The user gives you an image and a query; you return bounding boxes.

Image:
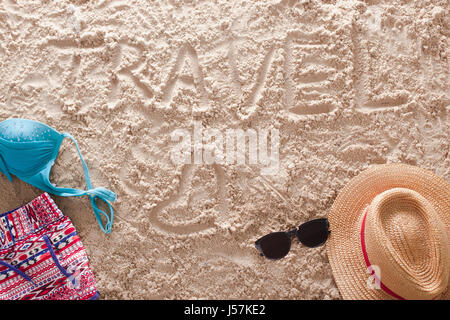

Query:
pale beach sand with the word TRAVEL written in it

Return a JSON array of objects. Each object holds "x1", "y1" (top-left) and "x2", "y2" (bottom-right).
[{"x1": 0, "y1": 0, "x2": 450, "y2": 299}]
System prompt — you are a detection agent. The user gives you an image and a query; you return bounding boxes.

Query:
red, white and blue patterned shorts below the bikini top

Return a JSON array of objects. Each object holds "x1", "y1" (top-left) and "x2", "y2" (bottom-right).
[{"x1": 0, "y1": 193, "x2": 98, "y2": 300}]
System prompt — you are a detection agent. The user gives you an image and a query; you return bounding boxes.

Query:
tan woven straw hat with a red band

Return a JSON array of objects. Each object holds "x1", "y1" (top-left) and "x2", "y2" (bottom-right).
[{"x1": 327, "y1": 164, "x2": 450, "y2": 299}]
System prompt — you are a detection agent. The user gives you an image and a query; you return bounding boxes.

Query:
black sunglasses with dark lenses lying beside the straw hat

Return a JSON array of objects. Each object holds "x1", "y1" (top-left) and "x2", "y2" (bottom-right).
[{"x1": 255, "y1": 218, "x2": 331, "y2": 260}]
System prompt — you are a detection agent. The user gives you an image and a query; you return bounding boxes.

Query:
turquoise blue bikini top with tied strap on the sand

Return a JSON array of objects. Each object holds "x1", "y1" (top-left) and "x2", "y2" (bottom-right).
[{"x1": 0, "y1": 119, "x2": 116, "y2": 233}]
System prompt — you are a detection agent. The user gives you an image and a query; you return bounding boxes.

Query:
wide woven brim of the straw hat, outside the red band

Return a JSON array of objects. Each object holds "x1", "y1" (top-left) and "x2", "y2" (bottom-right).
[{"x1": 327, "y1": 164, "x2": 450, "y2": 300}]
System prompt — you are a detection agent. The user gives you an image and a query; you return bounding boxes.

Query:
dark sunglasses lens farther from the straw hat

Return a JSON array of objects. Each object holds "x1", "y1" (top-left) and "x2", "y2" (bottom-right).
[{"x1": 255, "y1": 232, "x2": 291, "y2": 260}]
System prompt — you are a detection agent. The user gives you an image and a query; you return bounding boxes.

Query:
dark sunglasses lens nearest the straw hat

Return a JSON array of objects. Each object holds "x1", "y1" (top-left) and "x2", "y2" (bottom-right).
[{"x1": 297, "y1": 219, "x2": 329, "y2": 248}]
